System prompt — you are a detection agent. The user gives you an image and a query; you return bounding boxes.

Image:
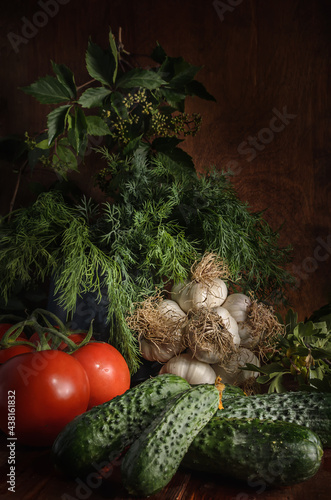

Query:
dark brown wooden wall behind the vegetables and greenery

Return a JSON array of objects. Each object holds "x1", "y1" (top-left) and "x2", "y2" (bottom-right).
[{"x1": 0, "y1": 0, "x2": 331, "y2": 319}]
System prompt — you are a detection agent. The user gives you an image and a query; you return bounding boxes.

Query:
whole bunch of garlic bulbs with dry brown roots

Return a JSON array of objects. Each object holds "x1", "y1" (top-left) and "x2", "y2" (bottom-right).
[{"x1": 128, "y1": 254, "x2": 277, "y2": 386}]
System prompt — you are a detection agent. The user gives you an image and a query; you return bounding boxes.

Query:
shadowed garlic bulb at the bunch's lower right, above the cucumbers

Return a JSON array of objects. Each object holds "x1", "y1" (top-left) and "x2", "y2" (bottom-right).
[{"x1": 212, "y1": 347, "x2": 260, "y2": 385}]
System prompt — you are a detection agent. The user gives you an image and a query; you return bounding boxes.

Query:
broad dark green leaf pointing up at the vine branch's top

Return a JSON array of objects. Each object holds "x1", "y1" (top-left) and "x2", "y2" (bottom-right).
[{"x1": 85, "y1": 41, "x2": 117, "y2": 85}]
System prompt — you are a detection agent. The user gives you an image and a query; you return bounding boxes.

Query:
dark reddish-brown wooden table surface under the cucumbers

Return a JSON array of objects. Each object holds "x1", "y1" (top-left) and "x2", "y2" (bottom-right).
[{"x1": 0, "y1": 434, "x2": 331, "y2": 500}]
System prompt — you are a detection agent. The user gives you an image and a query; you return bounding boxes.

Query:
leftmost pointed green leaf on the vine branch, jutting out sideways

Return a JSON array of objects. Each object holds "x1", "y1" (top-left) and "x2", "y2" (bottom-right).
[{"x1": 21, "y1": 75, "x2": 71, "y2": 104}]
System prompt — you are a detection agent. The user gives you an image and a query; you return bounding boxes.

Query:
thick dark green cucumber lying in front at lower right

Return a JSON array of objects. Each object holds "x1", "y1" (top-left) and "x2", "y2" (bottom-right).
[{"x1": 182, "y1": 417, "x2": 323, "y2": 487}]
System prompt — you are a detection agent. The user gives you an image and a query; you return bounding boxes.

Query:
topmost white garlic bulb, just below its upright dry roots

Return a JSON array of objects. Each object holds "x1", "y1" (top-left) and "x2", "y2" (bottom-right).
[{"x1": 171, "y1": 278, "x2": 228, "y2": 313}]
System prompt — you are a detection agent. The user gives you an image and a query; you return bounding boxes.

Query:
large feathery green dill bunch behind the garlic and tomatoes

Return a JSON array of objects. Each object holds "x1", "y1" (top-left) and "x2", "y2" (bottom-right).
[{"x1": 0, "y1": 150, "x2": 296, "y2": 373}]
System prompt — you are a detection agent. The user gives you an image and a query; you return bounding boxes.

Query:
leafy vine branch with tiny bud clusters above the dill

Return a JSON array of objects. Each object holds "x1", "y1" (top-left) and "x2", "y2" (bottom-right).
[{"x1": 16, "y1": 26, "x2": 214, "y2": 177}]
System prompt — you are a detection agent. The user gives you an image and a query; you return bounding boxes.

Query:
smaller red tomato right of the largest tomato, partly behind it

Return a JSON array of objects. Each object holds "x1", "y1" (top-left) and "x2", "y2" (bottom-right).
[{"x1": 71, "y1": 342, "x2": 130, "y2": 408}]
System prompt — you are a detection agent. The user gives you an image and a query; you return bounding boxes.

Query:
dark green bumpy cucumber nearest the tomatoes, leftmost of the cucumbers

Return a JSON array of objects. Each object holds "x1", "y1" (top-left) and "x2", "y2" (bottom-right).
[{"x1": 52, "y1": 374, "x2": 191, "y2": 477}]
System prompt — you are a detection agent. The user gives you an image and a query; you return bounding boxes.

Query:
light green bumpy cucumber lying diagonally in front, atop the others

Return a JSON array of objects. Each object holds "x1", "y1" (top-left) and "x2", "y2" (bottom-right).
[{"x1": 121, "y1": 385, "x2": 219, "y2": 496}]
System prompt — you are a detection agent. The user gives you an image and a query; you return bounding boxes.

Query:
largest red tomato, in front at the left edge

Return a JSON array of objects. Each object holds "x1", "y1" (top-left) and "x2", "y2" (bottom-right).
[{"x1": 0, "y1": 350, "x2": 90, "y2": 446}]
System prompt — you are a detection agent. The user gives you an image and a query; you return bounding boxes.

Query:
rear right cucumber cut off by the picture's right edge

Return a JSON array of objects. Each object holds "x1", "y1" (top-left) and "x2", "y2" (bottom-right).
[{"x1": 217, "y1": 391, "x2": 331, "y2": 448}]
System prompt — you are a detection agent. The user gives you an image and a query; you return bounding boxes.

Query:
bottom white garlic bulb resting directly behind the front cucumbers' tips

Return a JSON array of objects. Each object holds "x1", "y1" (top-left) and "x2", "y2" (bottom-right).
[{"x1": 160, "y1": 353, "x2": 216, "y2": 385}]
